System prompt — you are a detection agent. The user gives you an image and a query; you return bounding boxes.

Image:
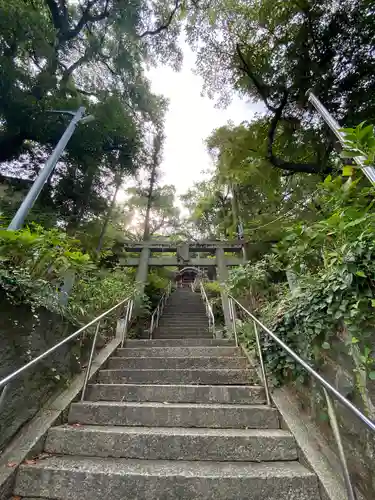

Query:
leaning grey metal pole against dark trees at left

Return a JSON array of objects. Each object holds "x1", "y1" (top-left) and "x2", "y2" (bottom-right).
[{"x1": 7, "y1": 106, "x2": 85, "y2": 231}]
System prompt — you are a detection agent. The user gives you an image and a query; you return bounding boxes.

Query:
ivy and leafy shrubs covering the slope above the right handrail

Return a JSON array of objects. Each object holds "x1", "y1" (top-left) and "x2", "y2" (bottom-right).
[{"x1": 230, "y1": 125, "x2": 375, "y2": 414}]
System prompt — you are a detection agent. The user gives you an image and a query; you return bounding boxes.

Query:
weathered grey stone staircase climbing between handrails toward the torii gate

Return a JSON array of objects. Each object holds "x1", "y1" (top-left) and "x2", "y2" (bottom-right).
[{"x1": 14, "y1": 289, "x2": 320, "y2": 500}]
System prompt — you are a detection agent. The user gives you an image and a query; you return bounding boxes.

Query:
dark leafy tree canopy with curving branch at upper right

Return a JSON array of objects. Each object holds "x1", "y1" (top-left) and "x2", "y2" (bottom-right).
[{"x1": 187, "y1": 0, "x2": 375, "y2": 174}]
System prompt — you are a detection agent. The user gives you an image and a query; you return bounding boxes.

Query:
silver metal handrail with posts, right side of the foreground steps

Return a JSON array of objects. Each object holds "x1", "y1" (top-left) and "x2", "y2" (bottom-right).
[{"x1": 228, "y1": 295, "x2": 375, "y2": 500}]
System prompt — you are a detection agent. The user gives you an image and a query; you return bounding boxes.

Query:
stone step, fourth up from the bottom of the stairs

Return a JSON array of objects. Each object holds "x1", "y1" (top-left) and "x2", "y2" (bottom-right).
[{"x1": 86, "y1": 384, "x2": 265, "y2": 404}]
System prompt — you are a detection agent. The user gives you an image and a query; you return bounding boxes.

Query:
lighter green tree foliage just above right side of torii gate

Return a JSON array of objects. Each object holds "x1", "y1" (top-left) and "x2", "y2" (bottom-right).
[{"x1": 183, "y1": 118, "x2": 319, "y2": 242}]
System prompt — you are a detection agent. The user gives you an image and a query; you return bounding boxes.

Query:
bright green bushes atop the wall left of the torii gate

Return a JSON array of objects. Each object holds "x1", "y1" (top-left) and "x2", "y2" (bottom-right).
[{"x1": 0, "y1": 225, "x2": 134, "y2": 324}]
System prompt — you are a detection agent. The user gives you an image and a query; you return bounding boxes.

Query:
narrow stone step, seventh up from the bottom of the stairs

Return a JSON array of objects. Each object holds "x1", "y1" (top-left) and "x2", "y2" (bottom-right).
[{"x1": 116, "y1": 347, "x2": 242, "y2": 358}]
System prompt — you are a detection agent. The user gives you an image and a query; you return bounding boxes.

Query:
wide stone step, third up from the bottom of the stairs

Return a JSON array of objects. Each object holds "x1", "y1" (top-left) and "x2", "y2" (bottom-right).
[{"x1": 68, "y1": 401, "x2": 279, "y2": 429}]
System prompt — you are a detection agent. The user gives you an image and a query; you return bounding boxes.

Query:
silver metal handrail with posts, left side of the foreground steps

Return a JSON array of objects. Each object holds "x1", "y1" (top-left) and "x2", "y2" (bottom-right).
[{"x1": 0, "y1": 297, "x2": 133, "y2": 409}]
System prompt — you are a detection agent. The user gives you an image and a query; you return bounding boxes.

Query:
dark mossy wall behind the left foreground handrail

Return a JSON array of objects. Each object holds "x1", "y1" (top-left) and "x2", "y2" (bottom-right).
[{"x1": 0, "y1": 291, "x2": 89, "y2": 451}]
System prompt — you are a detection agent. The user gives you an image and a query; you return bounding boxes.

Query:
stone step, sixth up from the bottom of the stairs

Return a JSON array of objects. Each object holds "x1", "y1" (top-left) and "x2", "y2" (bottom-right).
[{"x1": 108, "y1": 356, "x2": 249, "y2": 370}]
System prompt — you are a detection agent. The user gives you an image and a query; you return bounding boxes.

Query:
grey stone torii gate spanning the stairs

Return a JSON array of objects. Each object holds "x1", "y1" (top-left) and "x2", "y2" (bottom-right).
[{"x1": 120, "y1": 240, "x2": 244, "y2": 329}]
